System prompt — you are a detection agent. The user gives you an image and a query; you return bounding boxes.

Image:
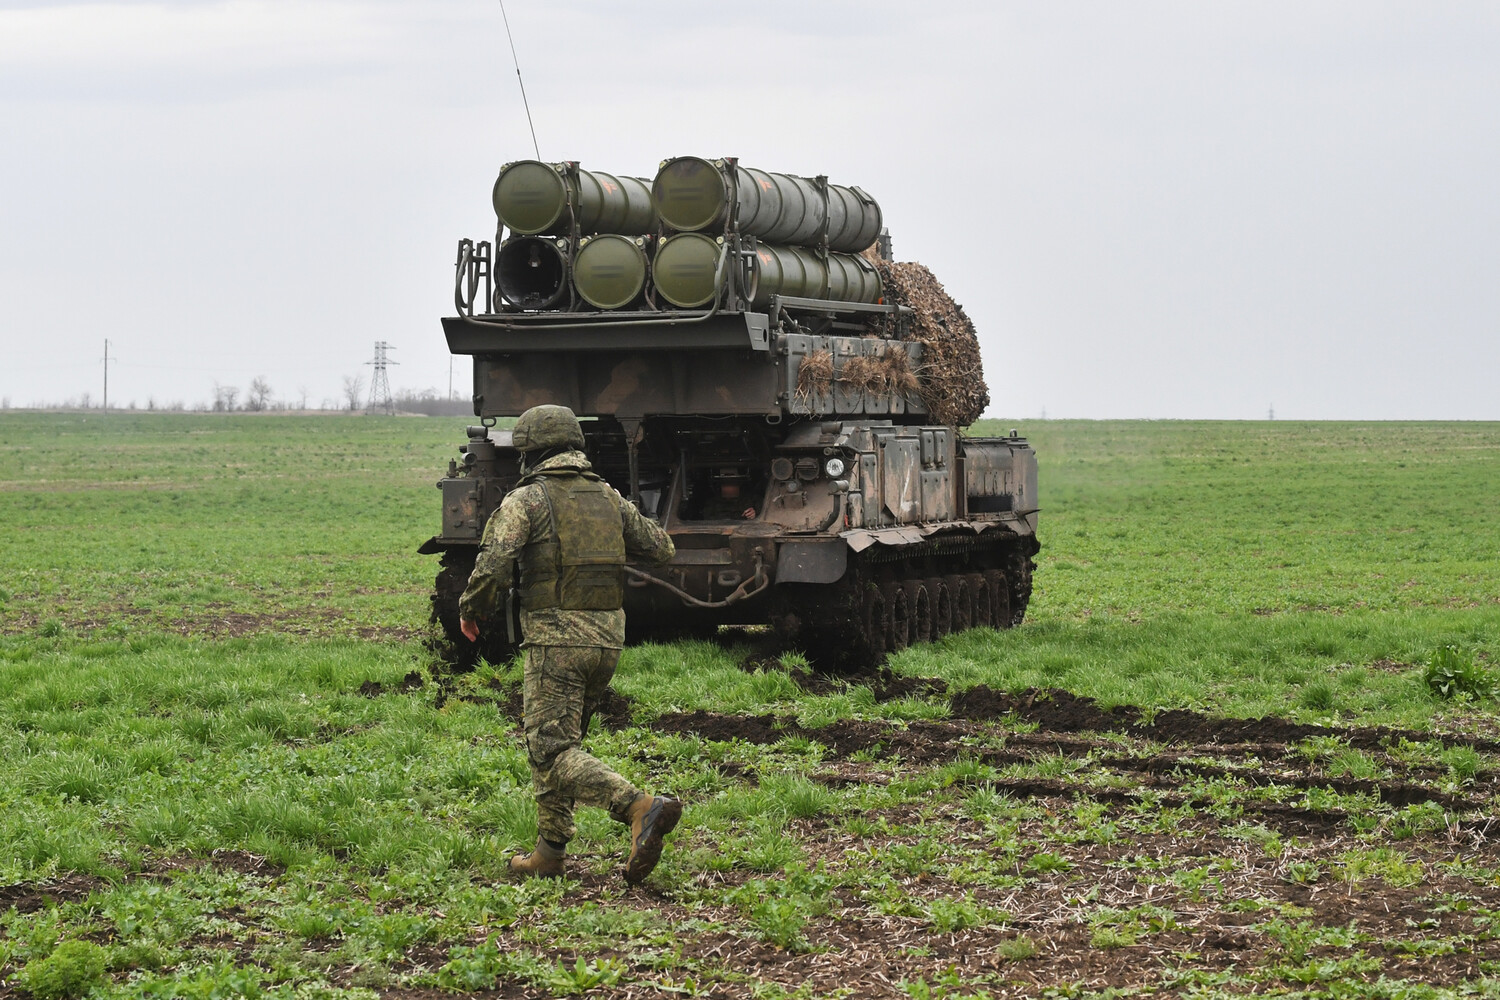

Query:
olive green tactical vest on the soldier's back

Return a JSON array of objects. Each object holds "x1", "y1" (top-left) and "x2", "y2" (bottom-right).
[{"x1": 521, "y1": 468, "x2": 626, "y2": 612}]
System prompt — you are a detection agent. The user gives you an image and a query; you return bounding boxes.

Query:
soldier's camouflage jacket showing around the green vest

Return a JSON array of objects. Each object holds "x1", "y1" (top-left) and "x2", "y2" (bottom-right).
[{"x1": 459, "y1": 451, "x2": 677, "y2": 649}]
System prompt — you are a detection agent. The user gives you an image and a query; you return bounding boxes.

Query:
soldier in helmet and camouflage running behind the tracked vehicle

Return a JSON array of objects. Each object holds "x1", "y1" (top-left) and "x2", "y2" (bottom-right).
[{"x1": 459, "y1": 405, "x2": 683, "y2": 885}]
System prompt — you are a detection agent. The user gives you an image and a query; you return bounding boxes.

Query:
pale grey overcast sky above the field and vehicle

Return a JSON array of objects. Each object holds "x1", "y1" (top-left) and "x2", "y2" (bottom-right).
[{"x1": 0, "y1": 0, "x2": 1500, "y2": 420}]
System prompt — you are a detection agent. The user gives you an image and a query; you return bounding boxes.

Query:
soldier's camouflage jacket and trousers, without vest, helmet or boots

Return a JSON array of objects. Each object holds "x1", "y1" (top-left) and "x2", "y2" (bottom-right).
[{"x1": 459, "y1": 450, "x2": 674, "y2": 843}]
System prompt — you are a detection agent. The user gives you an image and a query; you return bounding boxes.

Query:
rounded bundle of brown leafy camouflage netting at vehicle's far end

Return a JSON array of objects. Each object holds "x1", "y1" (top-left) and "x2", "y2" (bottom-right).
[{"x1": 864, "y1": 254, "x2": 990, "y2": 427}]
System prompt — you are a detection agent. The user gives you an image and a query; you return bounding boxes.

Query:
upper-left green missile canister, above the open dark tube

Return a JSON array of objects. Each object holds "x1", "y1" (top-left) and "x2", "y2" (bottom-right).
[{"x1": 494, "y1": 160, "x2": 657, "y2": 235}]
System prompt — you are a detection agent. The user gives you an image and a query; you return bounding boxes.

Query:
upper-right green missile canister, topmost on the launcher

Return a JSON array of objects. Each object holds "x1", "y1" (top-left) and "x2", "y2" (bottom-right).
[{"x1": 651, "y1": 156, "x2": 881, "y2": 253}]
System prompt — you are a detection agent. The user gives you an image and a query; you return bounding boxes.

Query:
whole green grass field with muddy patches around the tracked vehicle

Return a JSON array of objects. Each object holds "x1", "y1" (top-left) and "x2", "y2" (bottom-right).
[{"x1": 0, "y1": 412, "x2": 1500, "y2": 997}]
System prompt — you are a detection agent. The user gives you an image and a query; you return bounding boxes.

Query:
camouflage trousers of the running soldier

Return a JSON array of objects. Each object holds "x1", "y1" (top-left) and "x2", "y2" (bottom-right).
[{"x1": 525, "y1": 646, "x2": 641, "y2": 843}]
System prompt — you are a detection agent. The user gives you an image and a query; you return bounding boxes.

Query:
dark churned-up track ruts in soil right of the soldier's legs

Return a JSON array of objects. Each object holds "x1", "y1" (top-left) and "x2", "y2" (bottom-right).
[{"x1": 651, "y1": 687, "x2": 1500, "y2": 837}]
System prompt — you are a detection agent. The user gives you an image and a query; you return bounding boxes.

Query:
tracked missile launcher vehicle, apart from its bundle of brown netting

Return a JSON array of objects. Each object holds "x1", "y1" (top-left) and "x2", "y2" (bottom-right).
[{"x1": 420, "y1": 156, "x2": 1038, "y2": 667}]
